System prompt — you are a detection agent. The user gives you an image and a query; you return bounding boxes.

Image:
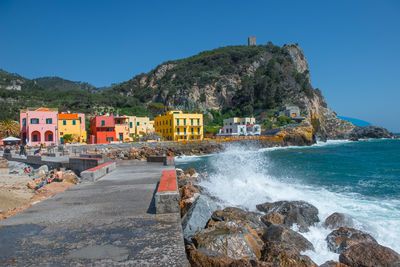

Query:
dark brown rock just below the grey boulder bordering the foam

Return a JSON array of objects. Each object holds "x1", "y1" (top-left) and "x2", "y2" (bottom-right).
[{"x1": 261, "y1": 224, "x2": 314, "y2": 251}]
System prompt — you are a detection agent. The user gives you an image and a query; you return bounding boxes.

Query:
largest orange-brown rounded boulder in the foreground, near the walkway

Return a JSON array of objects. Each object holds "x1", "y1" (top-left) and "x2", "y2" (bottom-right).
[{"x1": 192, "y1": 221, "x2": 263, "y2": 259}]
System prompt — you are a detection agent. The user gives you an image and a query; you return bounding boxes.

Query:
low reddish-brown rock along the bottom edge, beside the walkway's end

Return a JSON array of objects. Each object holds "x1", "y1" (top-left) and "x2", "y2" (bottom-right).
[{"x1": 187, "y1": 248, "x2": 272, "y2": 267}]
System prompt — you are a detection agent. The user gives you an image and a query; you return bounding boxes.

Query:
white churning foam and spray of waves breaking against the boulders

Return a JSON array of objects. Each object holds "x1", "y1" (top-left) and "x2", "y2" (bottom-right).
[{"x1": 177, "y1": 141, "x2": 400, "y2": 264}]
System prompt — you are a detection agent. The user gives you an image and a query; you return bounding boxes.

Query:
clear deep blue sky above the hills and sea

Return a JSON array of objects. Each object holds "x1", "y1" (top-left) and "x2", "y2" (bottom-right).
[{"x1": 0, "y1": 0, "x2": 400, "y2": 132}]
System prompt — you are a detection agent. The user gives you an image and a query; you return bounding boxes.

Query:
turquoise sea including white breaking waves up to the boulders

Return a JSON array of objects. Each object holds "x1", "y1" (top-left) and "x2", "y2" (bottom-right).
[{"x1": 176, "y1": 139, "x2": 400, "y2": 264}]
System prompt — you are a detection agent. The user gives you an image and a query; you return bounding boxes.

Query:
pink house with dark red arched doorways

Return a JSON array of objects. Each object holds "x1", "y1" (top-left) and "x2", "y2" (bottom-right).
[{"x1": 19, "y1": 108, "x2": 59, "y2": 146}]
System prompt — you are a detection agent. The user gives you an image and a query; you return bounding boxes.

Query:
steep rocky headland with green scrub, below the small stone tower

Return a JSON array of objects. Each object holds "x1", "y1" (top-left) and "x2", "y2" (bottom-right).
[{"x1": 113, "y1": 43, "x2": 354, "y2": 139}]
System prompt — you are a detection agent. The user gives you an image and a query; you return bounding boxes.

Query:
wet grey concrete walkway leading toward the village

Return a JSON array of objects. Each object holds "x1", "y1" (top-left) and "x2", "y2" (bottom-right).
[{"x1": 0, "y1": 161, "x2": 187, "y2": 266}]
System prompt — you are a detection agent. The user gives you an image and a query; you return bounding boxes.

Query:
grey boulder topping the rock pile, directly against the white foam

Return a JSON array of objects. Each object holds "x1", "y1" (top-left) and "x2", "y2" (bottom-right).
[{"x1": 256, "y1": 201, "x2": 319, "y2": 232}]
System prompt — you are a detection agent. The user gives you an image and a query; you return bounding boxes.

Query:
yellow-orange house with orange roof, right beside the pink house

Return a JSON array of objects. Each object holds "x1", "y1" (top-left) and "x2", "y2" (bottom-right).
[{"x1": 58, "y1": 113, "x2": 87, "y2": 144}]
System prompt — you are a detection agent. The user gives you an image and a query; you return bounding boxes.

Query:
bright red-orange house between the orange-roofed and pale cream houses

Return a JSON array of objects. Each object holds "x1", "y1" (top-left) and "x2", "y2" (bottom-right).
[{"x1": 89, "y1": 116, "x2": 117, "y2": 144}]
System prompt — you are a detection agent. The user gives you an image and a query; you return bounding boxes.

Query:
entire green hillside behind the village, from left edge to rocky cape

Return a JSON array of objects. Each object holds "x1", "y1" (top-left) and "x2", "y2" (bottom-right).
[{"x1": 0, "y1": 42, "x2": 354, "y2": 137}]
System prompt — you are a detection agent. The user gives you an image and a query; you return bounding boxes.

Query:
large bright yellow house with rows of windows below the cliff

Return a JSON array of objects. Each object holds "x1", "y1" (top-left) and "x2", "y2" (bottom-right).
[{"x1": 154, "y1": 111, "x2": 203, "y2": 141}]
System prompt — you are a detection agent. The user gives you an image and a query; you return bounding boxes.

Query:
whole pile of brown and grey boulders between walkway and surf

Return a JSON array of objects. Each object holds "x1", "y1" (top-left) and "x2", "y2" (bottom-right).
[{"x1": 177, "y1": 169, "x2": 400, "y2": 267}]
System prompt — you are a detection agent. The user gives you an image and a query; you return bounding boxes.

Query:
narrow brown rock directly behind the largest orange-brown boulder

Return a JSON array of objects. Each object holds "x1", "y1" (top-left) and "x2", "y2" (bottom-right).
[{"x1": 207, "y1": 207, "x2": 265, "y2": 234}]
